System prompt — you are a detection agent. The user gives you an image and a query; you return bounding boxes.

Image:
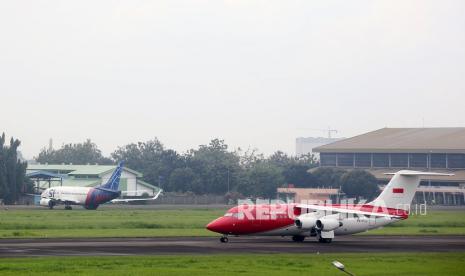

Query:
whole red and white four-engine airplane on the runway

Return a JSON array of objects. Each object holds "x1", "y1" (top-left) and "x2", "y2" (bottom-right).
[{"x1": 207, "y1": 170, "x2": 452, "y2": 243}]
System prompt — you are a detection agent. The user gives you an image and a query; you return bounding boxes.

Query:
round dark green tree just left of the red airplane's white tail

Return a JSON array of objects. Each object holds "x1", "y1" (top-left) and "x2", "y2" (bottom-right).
[{"x1": 341, "y1": 170, "x2": 379, "y2": 200}]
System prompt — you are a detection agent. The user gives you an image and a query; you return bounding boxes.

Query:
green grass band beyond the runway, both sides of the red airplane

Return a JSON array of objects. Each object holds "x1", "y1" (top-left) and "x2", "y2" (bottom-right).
[{"x1": 0, "y1": 207, "x2": 465, "y2": 238}]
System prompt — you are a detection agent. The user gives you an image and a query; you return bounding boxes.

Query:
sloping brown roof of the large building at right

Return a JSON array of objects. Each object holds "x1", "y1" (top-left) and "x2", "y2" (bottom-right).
[{"x1": 313, "y1": 127, "x2": 465, "y2": 153}]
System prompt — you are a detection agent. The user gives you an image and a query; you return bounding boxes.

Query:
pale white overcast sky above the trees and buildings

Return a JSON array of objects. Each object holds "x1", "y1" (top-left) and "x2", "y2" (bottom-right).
[{"x1": 0, "y1": 0, "x2": 465, "y2": 158}]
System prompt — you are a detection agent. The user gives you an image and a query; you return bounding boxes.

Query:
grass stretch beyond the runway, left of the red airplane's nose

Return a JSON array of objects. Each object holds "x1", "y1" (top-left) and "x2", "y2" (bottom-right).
[{"x1": 0, "y1": 208, "x2": 225, "y2": 238}]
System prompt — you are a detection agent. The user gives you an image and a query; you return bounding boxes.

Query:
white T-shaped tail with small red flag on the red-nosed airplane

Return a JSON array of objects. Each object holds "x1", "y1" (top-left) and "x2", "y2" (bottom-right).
[{"x1": 370, "y1": 170, "x2": 453, "y2": 210}]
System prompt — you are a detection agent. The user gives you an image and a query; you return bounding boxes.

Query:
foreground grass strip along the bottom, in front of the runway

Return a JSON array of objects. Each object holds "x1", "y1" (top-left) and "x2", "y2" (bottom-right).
[{"x1": 0, "y1": 253, "x2": 465, "y2": 276}]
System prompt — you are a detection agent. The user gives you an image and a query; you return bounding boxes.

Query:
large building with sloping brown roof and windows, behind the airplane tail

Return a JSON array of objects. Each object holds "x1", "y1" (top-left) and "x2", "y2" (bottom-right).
[{"x1": 314, "y1": 128, "x2": 465, "y2": 204}]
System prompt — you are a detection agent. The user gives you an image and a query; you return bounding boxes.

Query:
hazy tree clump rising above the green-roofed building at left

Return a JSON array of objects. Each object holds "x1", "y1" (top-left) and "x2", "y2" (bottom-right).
[{"x1": 35, "y1": 139, "x2": 113, "y2": 165}]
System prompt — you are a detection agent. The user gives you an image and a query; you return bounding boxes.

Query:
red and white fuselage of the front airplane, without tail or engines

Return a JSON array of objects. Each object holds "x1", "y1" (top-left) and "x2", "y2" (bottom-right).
[{"x1": 207, "y1": 204, "x2": 408, "y2": 237}]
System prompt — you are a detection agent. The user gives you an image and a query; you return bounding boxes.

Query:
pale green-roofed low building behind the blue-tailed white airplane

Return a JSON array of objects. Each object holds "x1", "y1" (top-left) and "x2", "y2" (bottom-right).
[{"x1": 26, "y1": 164, "x2": 159, "y2": 196}]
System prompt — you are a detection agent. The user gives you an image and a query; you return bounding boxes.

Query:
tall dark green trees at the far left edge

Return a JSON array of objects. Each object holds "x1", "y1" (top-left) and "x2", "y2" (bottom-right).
[{"x1": 0, "y1": 133, "x2": 31, "y2": 204}]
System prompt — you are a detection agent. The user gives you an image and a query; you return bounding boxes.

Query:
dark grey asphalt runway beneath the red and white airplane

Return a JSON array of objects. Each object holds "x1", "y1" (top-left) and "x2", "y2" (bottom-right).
[{"x1": 0, "y1": 236, "x2": 465, "y2": 257}]
